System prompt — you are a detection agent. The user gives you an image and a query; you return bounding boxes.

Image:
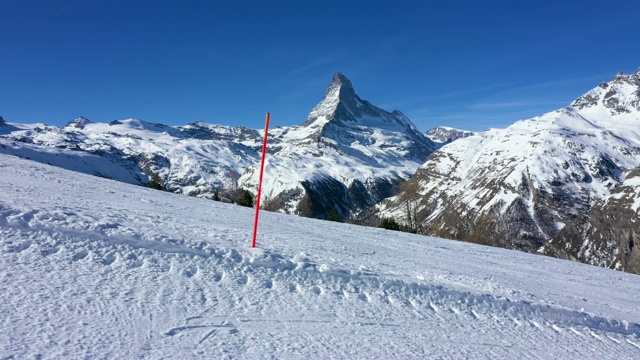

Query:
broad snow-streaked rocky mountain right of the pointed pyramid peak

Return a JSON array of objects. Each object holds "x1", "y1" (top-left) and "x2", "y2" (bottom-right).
[{"x1": 380, "y1": 71, "x2": 640, "y2": 255}]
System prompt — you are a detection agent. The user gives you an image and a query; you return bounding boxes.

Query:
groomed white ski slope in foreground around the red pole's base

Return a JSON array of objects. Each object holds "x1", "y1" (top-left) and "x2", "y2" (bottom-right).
[{"x1": 0, "y1": 155, "x2": 640, "y2": 359}]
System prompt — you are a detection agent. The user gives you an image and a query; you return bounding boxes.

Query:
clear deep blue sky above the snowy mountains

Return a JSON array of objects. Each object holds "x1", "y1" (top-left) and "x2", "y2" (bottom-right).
[{"x1": 0, "y1": 0, "x2": 640, "y2": 130}]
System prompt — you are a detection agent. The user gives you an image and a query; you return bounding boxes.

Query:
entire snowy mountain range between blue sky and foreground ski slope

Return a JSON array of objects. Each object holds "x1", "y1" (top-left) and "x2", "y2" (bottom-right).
[{"x1": 0, "y1": 71, "x2": 640, "y2": 272}]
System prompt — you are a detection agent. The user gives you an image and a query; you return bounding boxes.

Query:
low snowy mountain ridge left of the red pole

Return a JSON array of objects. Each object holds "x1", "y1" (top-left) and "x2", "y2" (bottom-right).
[{"x1": 0, "y1": 118, "x2": 259, "y2": 197}]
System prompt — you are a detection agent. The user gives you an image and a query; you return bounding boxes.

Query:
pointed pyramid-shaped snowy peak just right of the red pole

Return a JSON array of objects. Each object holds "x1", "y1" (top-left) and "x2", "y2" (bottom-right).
[{"x1": 240, "y1": 73, "x2": 436, "y2": 217}]
